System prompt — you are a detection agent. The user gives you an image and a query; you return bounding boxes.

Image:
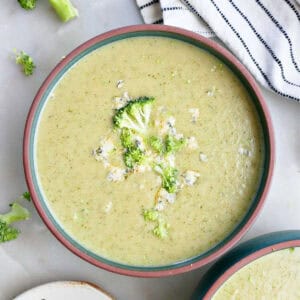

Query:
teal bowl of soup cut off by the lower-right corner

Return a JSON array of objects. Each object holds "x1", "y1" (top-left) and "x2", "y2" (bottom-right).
[{"x1": 193, "y1": 230, "x2": 300, "y2": 300}]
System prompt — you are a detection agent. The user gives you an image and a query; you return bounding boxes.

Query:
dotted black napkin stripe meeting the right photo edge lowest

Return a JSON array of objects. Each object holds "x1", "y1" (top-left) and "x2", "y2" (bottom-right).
[{"x1": 210, "y1": 0, "x2": 300, "y2": 102}]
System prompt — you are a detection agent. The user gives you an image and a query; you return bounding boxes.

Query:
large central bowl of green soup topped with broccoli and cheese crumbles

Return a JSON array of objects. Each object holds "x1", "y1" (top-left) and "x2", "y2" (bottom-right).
[{"x1": 24, "y1": 25, "x2": 274, "y2": 277}]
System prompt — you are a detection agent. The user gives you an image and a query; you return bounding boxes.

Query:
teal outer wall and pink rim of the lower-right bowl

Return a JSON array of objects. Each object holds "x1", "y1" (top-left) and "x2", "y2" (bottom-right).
[{"x1": 192, "y1": 230, "x2": 300, "y2": 300}]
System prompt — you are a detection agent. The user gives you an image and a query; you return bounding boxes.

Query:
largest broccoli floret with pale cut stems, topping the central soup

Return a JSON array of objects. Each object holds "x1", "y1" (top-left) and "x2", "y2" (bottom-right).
[{"x1": 113, "y1": 97, "x2": 154, "y2": 134}]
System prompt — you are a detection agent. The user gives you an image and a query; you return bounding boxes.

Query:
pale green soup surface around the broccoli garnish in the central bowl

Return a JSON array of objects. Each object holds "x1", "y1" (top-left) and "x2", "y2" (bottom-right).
[{"x1": 36, "y1": 37, "x2": 264, "y2": 266}]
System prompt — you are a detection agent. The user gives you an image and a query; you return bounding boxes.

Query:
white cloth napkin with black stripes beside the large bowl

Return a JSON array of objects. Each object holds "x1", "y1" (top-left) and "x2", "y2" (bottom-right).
[{"x1": 137, "y1": 0, "x2": 300, "y2": 102}]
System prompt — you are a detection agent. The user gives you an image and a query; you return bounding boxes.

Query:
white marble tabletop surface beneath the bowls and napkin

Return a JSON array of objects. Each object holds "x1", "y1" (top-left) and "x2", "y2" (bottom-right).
[{"x1": 0, "y1": 0, "x2": 300, "y2": 300}]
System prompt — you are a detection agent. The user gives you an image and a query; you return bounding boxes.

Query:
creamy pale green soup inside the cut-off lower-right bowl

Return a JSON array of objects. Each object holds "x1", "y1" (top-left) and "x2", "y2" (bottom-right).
[{"x1": 213, "y1": 247, "x2": 300, "y2": 300}]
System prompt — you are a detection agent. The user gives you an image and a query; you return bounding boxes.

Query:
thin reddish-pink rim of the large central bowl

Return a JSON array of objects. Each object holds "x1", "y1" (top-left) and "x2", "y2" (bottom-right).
[{"x1": 23, "y1": 25, "x2": 275, "y2": 277}]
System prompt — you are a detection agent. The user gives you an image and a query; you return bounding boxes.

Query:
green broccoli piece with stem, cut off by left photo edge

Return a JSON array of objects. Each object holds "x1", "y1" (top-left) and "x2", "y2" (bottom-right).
[{"x1": 0, "y1": 202, "x2": 30, "y2": 243}]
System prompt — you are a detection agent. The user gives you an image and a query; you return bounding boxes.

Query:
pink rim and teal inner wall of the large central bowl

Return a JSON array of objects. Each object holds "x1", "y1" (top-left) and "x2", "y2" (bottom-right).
[{"x1": 23, "y1": 25, "x2": 275, "y2": 277}]
